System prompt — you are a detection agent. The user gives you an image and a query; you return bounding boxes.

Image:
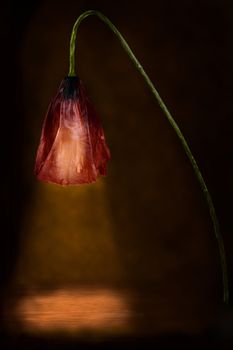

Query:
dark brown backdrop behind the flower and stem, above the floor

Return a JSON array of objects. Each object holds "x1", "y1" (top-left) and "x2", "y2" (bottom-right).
[{"x1": 0, "y1": 0, "x2": 233, "y2": 344}]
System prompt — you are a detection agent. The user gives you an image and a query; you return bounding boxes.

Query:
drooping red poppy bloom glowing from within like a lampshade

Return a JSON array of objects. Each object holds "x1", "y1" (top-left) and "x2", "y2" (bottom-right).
[{"x1": 35, "y1": 76, "x2": 110, "y2": 185}]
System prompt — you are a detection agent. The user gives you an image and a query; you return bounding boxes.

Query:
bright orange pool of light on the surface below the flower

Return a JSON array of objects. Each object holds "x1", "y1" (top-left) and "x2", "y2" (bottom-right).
[{"x1": 15, "y1": 288, "x2": 130, "y2": 334}]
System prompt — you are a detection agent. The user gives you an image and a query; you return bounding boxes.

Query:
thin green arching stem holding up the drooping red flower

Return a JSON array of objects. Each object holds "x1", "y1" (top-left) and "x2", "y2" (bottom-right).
[{"x1": 69, "y1": 10, "x2": 229, "y2": 304}]
